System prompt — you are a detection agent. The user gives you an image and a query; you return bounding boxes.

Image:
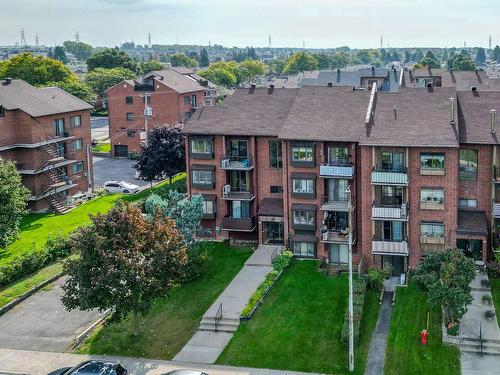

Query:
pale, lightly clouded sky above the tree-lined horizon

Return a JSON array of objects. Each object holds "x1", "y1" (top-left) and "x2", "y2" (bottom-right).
[{"x1": 0, "y1": 0, "x2": 500, "y2": 48}]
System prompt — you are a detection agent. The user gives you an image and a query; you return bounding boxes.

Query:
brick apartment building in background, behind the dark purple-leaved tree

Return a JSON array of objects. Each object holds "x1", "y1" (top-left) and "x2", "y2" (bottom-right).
[{"x1": 106, "y1": 69, "x2": 216, "y2": 157}]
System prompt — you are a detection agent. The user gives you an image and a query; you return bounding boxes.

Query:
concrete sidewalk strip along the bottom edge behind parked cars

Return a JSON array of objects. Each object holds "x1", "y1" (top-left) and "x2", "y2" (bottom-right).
[{"x1": 0, "y1": 349, "x2": 322, "y2": 375}]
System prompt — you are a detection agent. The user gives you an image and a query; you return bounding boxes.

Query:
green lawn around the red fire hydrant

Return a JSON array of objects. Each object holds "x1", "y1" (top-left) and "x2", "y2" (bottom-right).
[{"x1": 384, "y1": 283, "x2": 460, "y2": 375}]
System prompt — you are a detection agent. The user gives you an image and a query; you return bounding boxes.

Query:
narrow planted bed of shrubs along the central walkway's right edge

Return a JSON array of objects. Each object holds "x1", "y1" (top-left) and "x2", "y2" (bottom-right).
[{"x1": 240, "y1": 250, "x2": 293, "y2": 320}]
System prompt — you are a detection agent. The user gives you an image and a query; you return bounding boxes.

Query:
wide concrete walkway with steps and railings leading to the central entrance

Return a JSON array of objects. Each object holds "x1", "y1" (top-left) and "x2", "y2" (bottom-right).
[{"x1": 174, "y1": 245, "x2": 277, "y2": 363}]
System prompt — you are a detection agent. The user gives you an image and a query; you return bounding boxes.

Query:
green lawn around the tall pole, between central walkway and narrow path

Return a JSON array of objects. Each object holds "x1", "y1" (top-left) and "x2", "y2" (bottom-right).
[{"x1": 217, "y1": 261, "x2": 379, "y2": 374}]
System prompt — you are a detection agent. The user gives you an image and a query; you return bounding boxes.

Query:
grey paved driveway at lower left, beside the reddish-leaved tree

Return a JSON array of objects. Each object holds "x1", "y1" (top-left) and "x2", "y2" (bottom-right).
[{"x1": 0, "y1": 278, "x2": 101, "y2": 352}]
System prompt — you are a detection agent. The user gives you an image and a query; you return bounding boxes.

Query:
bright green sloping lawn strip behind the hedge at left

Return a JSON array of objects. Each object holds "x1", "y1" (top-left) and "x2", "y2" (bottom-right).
[{"x1": 0, "y1": 175, "x2": 185, "y2": 265}]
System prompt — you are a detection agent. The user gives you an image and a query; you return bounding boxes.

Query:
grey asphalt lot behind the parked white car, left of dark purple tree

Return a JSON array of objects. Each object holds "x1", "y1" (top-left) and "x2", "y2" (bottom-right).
[{"x1": 94, "y1": 156, "x2": 149, "y2": 187}]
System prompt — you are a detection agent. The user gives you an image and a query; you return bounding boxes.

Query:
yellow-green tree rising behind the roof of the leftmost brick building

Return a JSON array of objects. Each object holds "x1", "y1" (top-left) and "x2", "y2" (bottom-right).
[{"x1": 0, "y1": 53, "x2": 76, "y2": 86}]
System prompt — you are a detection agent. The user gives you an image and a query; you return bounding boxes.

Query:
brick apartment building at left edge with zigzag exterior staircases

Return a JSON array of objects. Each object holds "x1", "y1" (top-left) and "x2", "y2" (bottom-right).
[{"x1": 0, "y1": 78, "x2": 92, "y2": 211}]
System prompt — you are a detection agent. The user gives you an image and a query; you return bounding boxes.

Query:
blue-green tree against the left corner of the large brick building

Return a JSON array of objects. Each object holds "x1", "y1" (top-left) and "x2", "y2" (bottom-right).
[{"x1": 144, "y1": 190, "x2": 203, "y2": 246}]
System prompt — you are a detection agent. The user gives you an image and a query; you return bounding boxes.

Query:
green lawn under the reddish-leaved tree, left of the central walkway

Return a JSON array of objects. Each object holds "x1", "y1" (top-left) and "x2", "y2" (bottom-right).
[{"x1": 79, "y1": 242, "x2": 251, "y2": 359}]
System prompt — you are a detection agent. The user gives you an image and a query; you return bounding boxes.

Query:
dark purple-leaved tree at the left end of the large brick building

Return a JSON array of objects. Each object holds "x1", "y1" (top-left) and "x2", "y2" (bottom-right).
[{"x1": 137, "y1": 124, "x2": 186, "y2": 181}]
